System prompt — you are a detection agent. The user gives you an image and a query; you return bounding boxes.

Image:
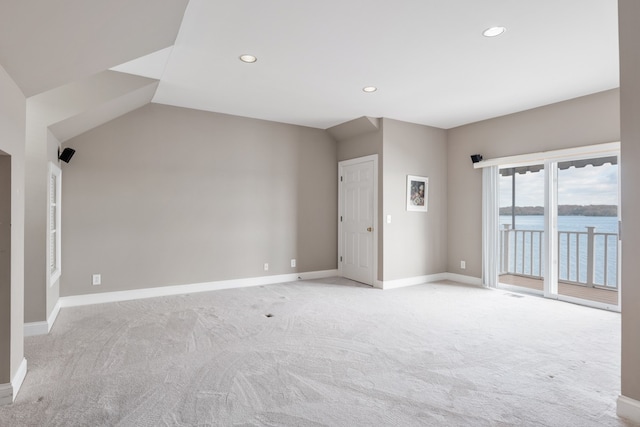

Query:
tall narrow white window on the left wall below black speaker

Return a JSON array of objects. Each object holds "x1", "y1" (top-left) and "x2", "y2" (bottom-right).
[{"x1": 48, "y1": 163, "x2": 62, "y2": 285}]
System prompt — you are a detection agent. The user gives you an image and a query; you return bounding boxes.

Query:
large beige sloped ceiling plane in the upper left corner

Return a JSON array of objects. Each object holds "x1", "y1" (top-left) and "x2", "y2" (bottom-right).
[{"x1": 0, "y1": 0, "x2": 188, "y2": 97}]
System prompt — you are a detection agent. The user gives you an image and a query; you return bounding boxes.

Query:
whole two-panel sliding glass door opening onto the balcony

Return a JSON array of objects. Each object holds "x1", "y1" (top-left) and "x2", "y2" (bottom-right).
[{"x1": 495, "y1": 152, "x2": 620, "y2": 311}]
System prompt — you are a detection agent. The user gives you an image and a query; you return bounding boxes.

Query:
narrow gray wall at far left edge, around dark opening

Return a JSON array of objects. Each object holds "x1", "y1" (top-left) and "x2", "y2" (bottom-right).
[{"x1": 0, "y1": 65, "x2": 26, "y2": 384}]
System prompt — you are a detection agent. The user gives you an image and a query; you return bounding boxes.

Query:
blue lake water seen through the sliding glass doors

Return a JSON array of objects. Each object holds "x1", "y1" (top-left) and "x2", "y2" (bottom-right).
[{"x1": 500, "y1": 215, "x2": 618, "y2": 288}]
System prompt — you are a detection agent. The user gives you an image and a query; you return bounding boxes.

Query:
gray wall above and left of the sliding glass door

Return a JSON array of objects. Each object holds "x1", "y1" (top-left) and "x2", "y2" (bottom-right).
[{"x1": 447, "y1": 89, "x2": 620, "y2": 277}]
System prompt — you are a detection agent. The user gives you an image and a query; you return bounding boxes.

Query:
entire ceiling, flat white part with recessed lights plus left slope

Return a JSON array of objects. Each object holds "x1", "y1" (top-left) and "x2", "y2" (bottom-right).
[{"x1": 0, "y1": 0, "x2": 618, "y2": 134}]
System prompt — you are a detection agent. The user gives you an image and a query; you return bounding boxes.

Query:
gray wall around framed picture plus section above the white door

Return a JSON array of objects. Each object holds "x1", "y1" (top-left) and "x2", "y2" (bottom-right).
[{"x1": 329, "y1": 118, "x2": 447, "y2": 281}]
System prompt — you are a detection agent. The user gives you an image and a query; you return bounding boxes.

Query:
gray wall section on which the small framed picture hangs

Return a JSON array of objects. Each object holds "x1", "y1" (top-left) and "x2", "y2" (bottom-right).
[{"x1": 382, "y1": 119, "x2": 447, "y2": 281}]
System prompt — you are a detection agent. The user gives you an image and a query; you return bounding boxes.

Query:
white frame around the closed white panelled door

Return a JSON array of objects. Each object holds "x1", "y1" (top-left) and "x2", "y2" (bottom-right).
[{"x1": 337, "y1": 154, "x2": 382, "y2": 288}]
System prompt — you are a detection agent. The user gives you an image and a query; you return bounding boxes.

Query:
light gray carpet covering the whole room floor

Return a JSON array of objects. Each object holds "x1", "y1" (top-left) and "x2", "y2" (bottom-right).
[{"x1": 0, "y1": 279, "x2": 631, "y2": 427}]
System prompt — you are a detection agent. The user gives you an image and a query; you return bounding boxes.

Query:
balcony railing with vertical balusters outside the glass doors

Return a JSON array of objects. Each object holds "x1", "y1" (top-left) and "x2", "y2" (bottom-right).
[{"x1": 500, "y1": 224, "x2": 618, "y2": 290}]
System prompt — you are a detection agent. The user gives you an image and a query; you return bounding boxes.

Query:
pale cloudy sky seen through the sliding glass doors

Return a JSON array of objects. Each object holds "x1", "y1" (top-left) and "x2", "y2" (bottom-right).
[{"x1": 499, "y1": 163, "x2": 618, "y2": 207}]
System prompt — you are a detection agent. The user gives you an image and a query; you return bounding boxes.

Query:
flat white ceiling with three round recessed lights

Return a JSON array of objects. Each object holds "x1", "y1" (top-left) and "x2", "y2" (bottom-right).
[{"x1": 100, "y1": 0, "x2": 619, "y2": 129}]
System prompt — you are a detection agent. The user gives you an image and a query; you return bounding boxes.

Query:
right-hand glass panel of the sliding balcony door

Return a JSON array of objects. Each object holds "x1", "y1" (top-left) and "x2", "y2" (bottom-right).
[{"x1": 557, "y1": 156, "x2": 619, "y2": 306}]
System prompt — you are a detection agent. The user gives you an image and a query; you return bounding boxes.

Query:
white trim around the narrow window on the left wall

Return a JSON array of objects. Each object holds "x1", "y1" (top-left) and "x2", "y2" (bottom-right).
[{"x1": 47, "y1": 162, "x2": 62, "y2": 286}]
